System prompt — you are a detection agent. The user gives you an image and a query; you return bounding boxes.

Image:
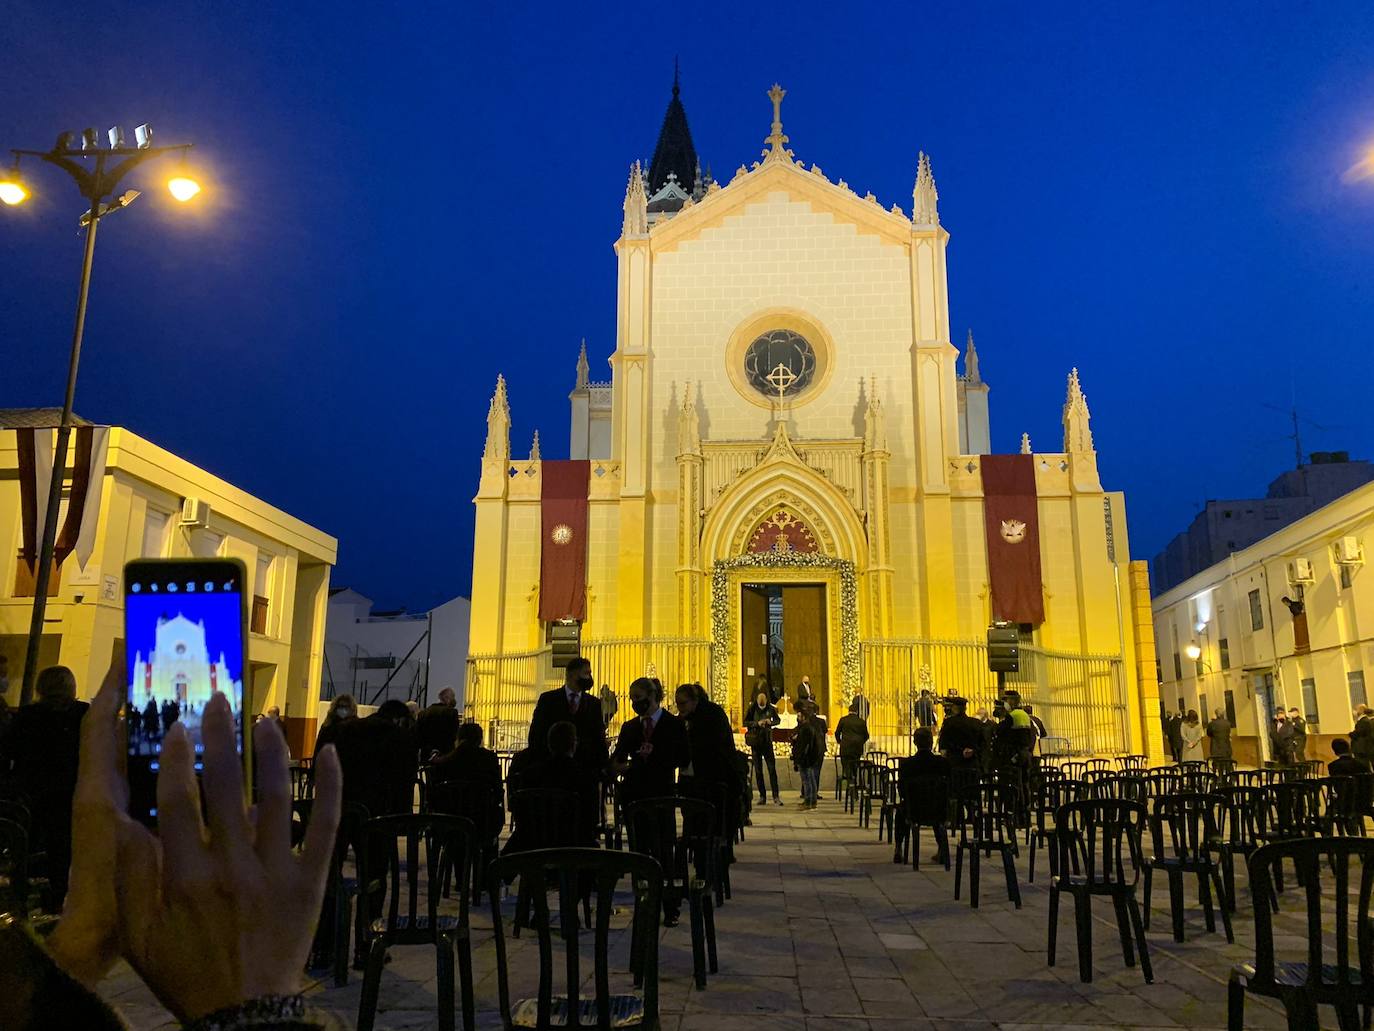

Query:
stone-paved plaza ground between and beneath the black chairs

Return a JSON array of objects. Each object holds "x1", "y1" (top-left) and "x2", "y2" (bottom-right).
[{"x1": 103, "y1": 764, "x2": 1297, "y2": 1031}]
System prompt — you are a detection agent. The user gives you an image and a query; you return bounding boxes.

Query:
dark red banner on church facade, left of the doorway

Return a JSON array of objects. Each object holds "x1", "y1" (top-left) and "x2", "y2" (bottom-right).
[{"x1": 539, "y1": 459, "x2": 592, "y2": 623}]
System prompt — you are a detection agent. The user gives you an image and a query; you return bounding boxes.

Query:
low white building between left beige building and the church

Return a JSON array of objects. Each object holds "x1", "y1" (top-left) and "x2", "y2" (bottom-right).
[{"x1": 320, "y1": 587, "x2": 471, "y2": 705}]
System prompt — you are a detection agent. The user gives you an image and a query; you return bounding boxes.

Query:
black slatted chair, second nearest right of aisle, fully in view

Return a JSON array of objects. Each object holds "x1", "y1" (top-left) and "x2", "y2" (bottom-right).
[{"x1": 1050, "y1": 799, "x2": 1154, "y2": 984}]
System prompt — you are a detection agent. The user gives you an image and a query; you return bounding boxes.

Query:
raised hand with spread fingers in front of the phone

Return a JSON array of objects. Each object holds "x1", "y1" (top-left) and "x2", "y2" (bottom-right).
[{"x1": 117, "y1": 694, "x2": 342, "y2": 1021}]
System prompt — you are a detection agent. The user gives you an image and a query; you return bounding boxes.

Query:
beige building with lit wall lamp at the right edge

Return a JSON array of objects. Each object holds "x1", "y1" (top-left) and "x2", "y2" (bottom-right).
[{"x1": 1154, "y1": 484, "x2": 1374, "y2": 762}]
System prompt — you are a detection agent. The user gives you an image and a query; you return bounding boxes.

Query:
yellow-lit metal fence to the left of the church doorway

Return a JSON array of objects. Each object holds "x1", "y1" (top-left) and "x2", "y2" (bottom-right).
[{"x1": 466, "y1": 638, "x2": 710, "y2": 749}]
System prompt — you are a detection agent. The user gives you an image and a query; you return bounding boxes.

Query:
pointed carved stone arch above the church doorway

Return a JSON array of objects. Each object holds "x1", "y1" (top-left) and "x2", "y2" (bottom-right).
[{"x1": 701, "y1": 445, "x2": 868, "y2": 570}]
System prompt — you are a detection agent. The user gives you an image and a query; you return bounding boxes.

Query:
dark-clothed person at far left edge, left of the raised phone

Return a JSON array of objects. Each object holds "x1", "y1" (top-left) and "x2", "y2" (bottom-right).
[{"x1": 0, "y1": 665, "x2": 91, "y2": 913}]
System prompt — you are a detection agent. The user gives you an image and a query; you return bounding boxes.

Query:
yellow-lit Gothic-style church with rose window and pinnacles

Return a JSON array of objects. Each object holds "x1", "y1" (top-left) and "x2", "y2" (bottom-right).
[{"x1": 467, "y1": 84, "x2": 1158, "y2": 753}]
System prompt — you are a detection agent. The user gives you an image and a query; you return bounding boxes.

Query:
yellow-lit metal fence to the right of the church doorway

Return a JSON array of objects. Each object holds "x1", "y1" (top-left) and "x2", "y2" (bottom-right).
[{"x1": 860, "y1": 641, "x2": 1131, "y2": 755}]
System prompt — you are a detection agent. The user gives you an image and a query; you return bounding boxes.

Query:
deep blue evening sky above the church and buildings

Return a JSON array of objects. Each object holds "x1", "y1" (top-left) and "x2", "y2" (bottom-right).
[{"x1": 0, "y1": 0, "x2": 1374, "y2": 609}]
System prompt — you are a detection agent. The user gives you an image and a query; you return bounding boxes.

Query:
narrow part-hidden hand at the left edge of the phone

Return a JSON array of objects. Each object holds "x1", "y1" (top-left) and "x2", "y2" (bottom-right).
[{"x1": 47, "y1": 643, "x2": 129, "y2": 988}]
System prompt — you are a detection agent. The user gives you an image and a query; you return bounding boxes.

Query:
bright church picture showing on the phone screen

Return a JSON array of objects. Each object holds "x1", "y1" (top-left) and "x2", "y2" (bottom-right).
[{"x1": 125, "y1": 594, "x2": 243, "y2": 756}]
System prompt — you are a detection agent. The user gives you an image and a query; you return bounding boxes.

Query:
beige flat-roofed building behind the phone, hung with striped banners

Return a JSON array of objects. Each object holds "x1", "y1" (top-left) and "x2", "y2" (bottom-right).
[{"x1": 0, "y1": 410, "x2": 338, "y2": 755}]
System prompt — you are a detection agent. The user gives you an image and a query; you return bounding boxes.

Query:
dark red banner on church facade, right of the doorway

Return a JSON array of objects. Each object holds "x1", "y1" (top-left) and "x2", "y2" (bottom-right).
[{"x1": 980, "y1": 455, "x2": 1044, "y2": 624}]
